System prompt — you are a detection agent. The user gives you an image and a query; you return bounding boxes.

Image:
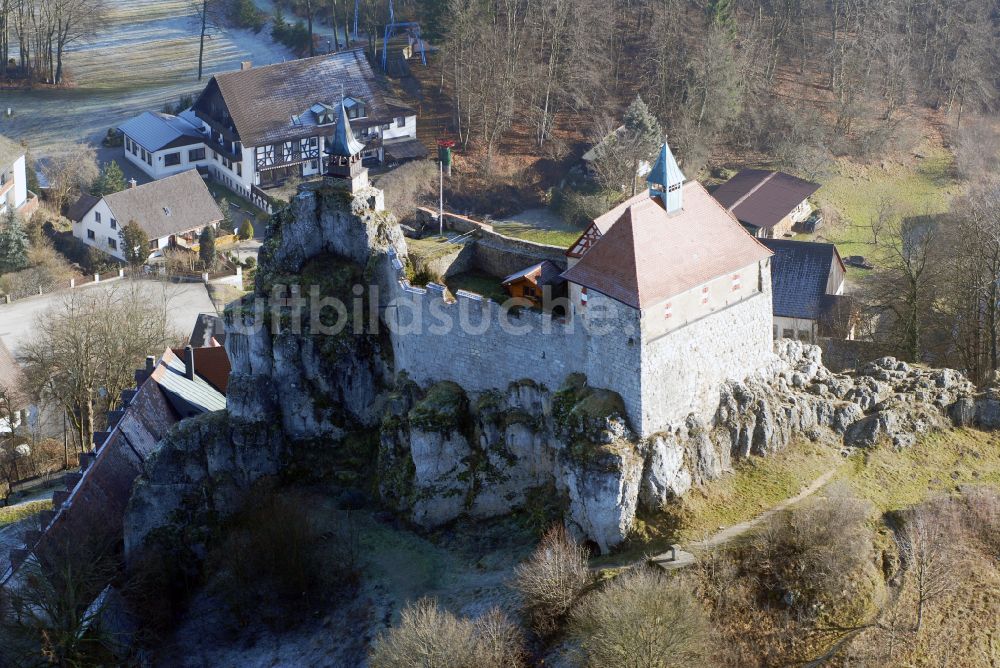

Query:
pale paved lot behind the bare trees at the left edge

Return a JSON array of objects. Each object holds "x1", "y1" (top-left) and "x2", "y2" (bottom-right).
[{"x1": 0, "y1": 280, "x2": 215, "y2": 355}]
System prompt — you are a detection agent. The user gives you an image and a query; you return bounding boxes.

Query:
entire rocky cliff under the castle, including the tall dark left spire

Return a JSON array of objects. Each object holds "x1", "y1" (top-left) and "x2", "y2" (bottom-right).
[{"x1": 126, "y1": 183, "x2": 984, "y2": 554}]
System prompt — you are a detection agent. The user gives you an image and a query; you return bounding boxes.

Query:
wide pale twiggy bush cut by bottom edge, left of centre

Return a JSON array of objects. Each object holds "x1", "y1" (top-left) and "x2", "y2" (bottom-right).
[{"x1": 369, "y1": 598, "x2": 524, "y2": 668}]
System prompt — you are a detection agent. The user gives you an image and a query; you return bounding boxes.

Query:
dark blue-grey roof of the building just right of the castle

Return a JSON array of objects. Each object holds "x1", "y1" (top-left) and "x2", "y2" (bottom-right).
[{"x1": 760, "y1": 239, "x2": 838, "y2": 320}]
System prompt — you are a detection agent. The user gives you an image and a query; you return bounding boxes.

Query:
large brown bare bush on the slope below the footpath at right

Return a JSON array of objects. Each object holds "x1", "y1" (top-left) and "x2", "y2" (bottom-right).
[{"x1": 744, "y1": 482, "x2": 873, "y2": 611}]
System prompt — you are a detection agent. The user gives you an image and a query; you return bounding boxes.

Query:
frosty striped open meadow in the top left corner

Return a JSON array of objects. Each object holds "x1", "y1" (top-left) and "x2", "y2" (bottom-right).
[{"x1": 0, "y1": 0, "x2": 292, "y2": 157}]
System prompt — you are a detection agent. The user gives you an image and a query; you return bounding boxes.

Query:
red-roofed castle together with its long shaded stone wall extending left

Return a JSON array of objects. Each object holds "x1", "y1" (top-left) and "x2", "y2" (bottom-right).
[{"x1": 391, "y1": 144, "x2": 774, "y2": 437}]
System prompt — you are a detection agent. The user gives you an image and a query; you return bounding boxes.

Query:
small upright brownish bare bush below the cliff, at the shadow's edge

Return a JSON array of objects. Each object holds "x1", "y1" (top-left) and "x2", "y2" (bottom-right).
[{"x1": 514, "y1": 525, "x2": 590, "y2": 636}]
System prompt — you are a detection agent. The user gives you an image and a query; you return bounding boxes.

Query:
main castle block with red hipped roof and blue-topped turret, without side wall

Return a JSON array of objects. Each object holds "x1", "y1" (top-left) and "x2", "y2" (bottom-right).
[{"x1": 563, "y1": 143, "x2": 772, "y2": 435}]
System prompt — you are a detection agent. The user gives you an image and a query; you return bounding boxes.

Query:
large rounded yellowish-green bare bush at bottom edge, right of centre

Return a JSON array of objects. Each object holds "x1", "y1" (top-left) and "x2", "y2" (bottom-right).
[{"x1": 570, "y1": 568, "x2": 711, "y2": 668}]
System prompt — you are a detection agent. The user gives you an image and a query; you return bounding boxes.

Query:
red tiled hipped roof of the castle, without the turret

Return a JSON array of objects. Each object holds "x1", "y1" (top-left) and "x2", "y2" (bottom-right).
[{"x1": 563, "y1": 181, "x2": 771, "y2": 309}]
